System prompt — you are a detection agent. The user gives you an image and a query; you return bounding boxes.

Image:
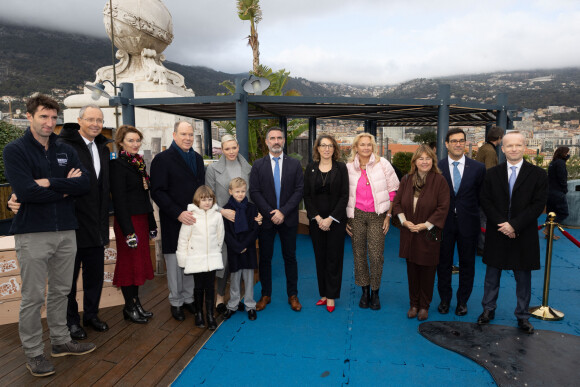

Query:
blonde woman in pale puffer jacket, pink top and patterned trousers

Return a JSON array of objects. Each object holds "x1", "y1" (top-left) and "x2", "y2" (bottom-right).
[{"x1": 346, "y1": 133, "x2": 399, "y2": 310}]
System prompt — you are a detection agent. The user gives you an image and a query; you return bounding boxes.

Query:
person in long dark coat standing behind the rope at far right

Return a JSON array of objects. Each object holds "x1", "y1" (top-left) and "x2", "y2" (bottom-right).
[{"x1": 544, "y1": 146, "x2": 570, "y2": 230}]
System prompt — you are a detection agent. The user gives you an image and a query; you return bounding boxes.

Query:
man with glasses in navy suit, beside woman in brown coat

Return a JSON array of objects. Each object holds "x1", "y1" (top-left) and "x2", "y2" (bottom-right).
[{"x1": 437, "y1": 129, "x2": 485, "y2": 316}]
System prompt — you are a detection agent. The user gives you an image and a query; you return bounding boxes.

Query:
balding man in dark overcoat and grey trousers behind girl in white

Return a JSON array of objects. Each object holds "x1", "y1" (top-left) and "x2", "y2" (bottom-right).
[{"x1": 151, "y1": 121, "x2": 205, "y2": 321}]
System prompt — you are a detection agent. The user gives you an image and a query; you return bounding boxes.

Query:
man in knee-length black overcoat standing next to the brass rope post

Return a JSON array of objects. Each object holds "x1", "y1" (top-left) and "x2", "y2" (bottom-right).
[{"x1": 477, "y1": 131, "x2": 548, "y2": 333}]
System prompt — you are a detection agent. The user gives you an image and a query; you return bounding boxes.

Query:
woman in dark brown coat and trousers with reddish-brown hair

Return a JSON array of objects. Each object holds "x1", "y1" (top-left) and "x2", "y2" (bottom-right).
[{"x1": 393, "y1": 145, "x2": 450, "y2": 321}]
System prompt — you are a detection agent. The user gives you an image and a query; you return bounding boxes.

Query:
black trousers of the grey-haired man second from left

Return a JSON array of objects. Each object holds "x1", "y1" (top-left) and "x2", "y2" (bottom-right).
[{"x1": 66, "y1": 246, "x2": 105, "y2": 327}]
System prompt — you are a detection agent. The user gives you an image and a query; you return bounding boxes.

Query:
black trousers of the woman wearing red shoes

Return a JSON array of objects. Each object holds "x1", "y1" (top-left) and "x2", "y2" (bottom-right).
[{"x1": 310, "y1": 220, "x2": 346, "y2": 299}]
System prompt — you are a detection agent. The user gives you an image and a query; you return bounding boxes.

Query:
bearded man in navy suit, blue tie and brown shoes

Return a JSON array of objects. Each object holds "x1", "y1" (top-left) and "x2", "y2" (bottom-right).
[{"x1": 250, "y1": 127, "x2": 304, "y2": 312}]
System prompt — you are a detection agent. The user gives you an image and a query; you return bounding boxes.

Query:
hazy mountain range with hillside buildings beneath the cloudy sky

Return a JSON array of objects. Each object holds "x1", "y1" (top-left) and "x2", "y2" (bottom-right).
[{"x1": 0, "y1": 20, "x2": 580, "y2": 111}]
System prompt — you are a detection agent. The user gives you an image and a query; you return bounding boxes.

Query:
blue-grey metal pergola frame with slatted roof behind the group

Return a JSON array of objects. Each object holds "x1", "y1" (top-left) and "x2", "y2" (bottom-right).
[{"x1": 109, "y1": 79, "x2": 516, "y2": 159}]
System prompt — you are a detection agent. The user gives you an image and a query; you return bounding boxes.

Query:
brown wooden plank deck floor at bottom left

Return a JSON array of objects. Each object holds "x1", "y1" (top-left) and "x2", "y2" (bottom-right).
[{"x1": 0, "y1": 276, "x2": 208, "y2": 386}]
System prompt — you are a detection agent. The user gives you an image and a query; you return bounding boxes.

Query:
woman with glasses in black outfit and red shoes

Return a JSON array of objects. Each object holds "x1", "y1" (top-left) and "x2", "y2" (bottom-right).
[{"x1": 304, "y1": 134, "x2": 348, "y2": 312}]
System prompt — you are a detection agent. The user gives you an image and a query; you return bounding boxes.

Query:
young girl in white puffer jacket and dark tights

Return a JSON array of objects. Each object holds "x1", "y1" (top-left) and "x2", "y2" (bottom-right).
[{"x1": 176, "y1": 185, "x2": 224, "y2": 330}]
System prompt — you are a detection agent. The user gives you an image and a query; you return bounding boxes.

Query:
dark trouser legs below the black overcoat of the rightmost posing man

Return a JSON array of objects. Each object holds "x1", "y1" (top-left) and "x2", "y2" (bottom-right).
[{"x1": 481, "y1": 265, "x2": 532, "y2": 319}]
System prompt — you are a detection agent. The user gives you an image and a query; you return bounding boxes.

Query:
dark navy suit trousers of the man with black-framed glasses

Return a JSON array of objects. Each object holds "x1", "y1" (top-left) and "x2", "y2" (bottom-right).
[{"x1": 437, "y1": 217, "x2": 478, "y2": 304}]
